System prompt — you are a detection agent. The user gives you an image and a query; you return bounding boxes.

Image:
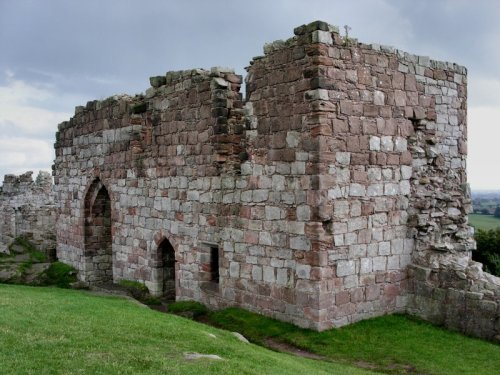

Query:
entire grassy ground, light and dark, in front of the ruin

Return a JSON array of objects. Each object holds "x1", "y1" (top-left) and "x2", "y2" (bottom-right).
[{"x1": 0, "y1": 284, "x2": 500, "y2": 375}]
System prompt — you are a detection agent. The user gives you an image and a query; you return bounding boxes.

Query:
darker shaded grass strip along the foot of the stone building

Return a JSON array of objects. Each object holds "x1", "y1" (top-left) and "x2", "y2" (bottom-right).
[{"x1": 210, "y1": 308, "x2": 500, "y2": 375}]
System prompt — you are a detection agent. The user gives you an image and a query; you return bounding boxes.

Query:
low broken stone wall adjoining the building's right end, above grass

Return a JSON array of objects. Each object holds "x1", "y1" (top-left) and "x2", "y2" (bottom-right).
[{"x1": 407, "y1": 261, "x2": 500, "y2": 342}]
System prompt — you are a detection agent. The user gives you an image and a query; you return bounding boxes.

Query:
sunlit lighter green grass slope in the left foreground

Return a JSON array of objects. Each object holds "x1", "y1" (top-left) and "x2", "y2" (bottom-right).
[{"x1": 0, "y1": 284, "x2": 369, "y2": 375}]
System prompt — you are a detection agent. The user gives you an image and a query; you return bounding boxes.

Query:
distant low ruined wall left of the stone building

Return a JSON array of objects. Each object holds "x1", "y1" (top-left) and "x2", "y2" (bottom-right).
[{"x1": 0, "y1": 172, "x2": 56, "y2": 256}]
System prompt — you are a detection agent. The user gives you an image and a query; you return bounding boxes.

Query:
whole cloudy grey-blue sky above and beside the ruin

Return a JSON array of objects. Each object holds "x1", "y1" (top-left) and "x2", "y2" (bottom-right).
[{"x1": 0, "y1": 0, "x2": 500, "y2": 189}]
